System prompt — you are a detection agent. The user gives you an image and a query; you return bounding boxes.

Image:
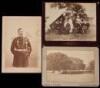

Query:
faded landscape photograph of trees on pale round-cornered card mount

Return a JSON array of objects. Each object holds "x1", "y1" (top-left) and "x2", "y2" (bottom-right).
[{"x1": 42, "y1": 47, "x2": 99, "y2": 87}]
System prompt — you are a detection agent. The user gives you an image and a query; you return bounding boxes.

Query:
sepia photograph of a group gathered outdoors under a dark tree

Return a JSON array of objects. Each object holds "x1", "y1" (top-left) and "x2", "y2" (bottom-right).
[{"x1": 44, "y1": 2, "x2": 97, "y2": 41}]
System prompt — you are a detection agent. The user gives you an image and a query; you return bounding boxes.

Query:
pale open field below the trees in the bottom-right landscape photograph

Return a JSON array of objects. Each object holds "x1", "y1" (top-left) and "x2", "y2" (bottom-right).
[{"x1": 46, "y1": 72, "x2": 94, "y2": 83}]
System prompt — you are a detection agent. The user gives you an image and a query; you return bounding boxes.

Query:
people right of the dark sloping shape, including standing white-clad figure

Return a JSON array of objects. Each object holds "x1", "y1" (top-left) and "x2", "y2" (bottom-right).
[{"x1": 64, "y1": 16, "x2": 90, "y2": 34}]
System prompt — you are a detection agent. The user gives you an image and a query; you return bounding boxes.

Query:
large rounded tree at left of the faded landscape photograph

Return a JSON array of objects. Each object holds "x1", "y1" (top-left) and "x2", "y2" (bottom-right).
[{"x1": 47, "y1": 52, "x2": 72, "y2": 70}]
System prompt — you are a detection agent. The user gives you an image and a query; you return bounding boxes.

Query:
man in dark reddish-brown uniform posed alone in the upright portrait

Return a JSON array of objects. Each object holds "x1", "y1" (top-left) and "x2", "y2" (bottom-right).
[{"x1": 11, "y1": 28, "x2": 32, "y2": 67}]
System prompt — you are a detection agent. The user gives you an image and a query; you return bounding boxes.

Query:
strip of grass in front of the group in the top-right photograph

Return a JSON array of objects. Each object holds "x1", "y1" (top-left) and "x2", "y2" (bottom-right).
[{"x1": 45, "y1": 26, "x2": 96, "y2": 41}]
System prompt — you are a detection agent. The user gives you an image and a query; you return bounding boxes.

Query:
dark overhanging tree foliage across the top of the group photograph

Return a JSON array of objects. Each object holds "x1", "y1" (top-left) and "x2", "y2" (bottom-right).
[{"x1": 51, "y1": 2, "x2": 87, "y2": 19}]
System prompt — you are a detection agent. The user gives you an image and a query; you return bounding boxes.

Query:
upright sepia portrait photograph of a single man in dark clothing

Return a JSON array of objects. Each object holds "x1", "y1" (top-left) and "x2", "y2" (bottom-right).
[{"x1": 2, "y1": 16, "x2": 41, "y2": 73}]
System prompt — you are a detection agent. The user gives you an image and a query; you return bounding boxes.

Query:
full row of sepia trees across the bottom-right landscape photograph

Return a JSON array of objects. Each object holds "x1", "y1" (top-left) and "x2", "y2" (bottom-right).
[{"x1": 47, "y1": 52, "x2": 94, "y2": 71}]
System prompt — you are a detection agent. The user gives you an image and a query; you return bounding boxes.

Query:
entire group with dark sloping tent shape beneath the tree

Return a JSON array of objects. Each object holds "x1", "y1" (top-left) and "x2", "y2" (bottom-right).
[{"x1": 50, "y1": 11, "x2": 90, "y2": 34}]
